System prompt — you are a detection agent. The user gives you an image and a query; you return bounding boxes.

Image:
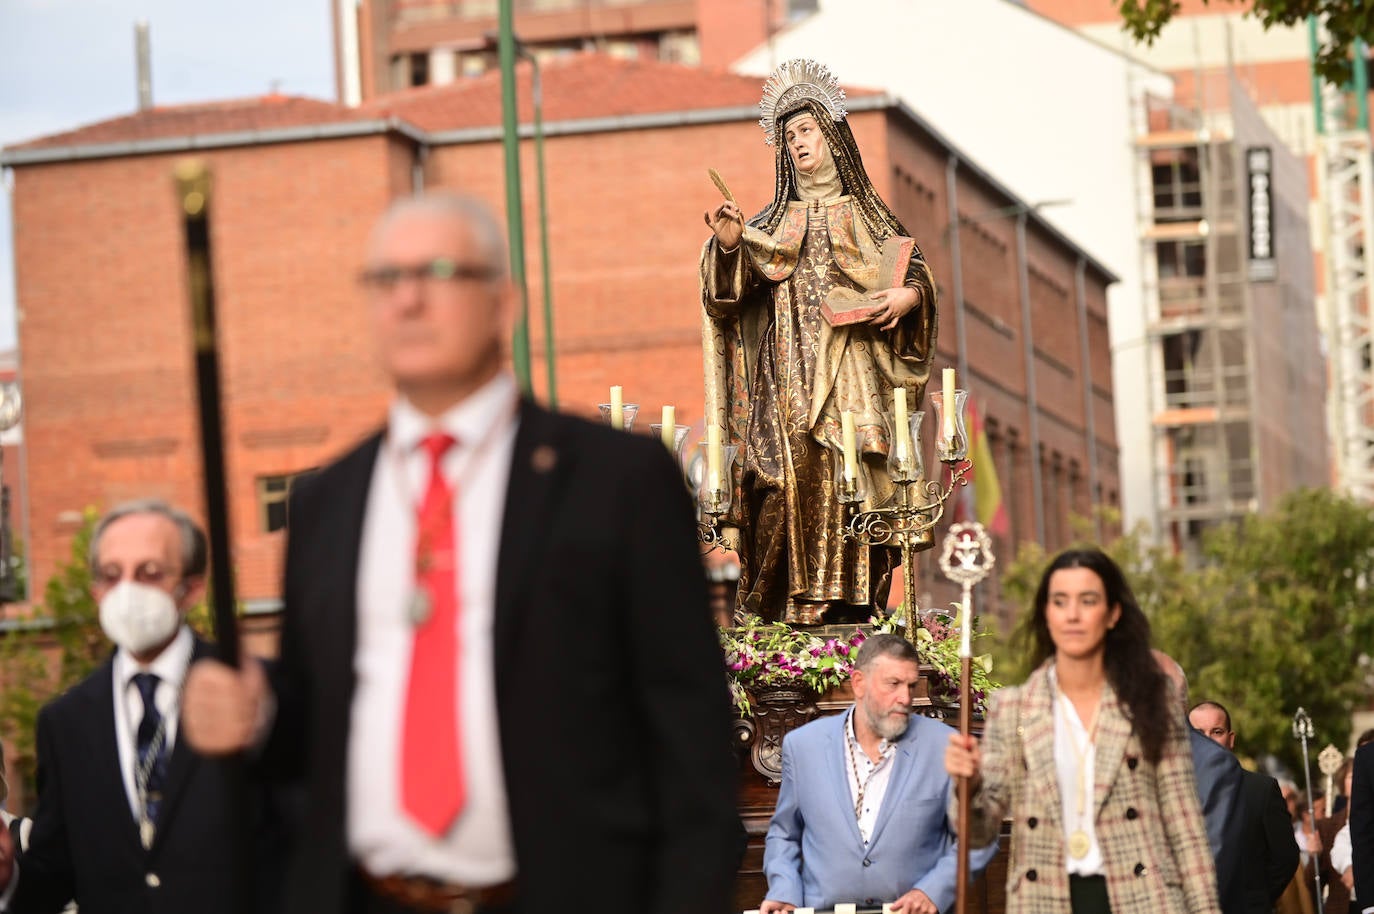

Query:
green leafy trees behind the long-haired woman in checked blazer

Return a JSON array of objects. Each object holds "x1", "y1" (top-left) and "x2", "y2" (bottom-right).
[{"x1": 1002, "y1": 489, "x2": 1374, "y2": 771}]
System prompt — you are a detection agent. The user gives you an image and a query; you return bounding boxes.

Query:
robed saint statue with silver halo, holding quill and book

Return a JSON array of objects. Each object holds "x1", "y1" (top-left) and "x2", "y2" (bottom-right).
[{"x1": 701, "y1": 60, "x2": 937, "y2": 624}]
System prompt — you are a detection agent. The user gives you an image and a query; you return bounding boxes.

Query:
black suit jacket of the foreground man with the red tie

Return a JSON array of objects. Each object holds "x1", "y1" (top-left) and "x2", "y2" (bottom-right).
[{"x1": 264, "y1": 403, "x2": 741, "y2": 914}]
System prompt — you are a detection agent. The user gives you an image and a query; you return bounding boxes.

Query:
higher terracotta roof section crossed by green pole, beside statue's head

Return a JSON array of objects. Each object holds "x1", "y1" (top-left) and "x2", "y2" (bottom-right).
[{"x1": 363, "y1": 54, "x2": 875, "y2": 131}]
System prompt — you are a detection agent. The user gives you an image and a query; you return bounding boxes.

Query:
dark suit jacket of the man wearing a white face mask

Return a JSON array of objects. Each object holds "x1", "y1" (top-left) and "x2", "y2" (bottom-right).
[{"x1": 10, "y1": 642, "x2": 274, "y2": 914}]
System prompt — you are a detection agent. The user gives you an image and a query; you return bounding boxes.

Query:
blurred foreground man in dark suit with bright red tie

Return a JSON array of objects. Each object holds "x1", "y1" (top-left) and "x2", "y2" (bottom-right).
[{"x1": 187, "y1": 195, "x2": 741, "y2": 914}]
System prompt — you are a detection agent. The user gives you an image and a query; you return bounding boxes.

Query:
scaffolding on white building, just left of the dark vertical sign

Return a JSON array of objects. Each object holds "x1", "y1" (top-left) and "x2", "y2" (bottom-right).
[{"x1": 1135, "y1": 92, "x2": 1257, "y2": 554}]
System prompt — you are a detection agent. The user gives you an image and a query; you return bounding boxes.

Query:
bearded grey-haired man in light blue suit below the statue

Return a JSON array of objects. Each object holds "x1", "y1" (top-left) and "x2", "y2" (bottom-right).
[{"x1": 760, "y1": 635, "x2": 998, "y2": 914}]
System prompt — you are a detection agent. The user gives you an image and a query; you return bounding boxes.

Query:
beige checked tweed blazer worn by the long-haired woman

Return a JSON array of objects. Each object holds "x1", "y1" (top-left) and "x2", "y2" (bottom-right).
[{"x1": 951, "y1": 660, "x2": 1220, "y2": 914}]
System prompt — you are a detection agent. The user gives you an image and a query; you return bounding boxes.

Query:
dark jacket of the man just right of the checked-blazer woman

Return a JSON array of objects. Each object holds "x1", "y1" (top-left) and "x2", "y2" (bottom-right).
[{"x1": 1221, "y1": 768, "x2": 1298, "y2": 914}]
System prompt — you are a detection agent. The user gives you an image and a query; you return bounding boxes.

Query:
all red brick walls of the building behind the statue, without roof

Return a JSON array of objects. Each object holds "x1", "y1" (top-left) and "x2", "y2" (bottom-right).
[{"x1": 14, "y1": 105, "x2": 1116, "y2": 621}]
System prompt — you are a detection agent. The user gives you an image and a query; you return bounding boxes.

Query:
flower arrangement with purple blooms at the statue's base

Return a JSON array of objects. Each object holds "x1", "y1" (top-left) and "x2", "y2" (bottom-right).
[{"x1": 720, "y1": 610, "x2": 996, "y2": 717}]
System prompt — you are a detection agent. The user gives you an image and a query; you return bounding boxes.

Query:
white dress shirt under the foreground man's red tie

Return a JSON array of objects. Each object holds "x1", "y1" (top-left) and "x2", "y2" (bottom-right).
[{"x1": 348, "y1": 374, "x2": 518, "y2": 885}]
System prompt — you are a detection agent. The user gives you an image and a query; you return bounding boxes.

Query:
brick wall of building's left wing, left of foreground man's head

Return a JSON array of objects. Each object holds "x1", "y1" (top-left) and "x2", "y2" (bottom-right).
[{"x1": 14, "y1": 129, "x2": 404, "y2": 598}]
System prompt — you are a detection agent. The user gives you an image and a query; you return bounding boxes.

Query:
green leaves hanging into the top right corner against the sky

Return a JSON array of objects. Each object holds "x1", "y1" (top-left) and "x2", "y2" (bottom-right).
[{"x1": 1117, "y1": 0, "x2": 1374, "y2": 84}]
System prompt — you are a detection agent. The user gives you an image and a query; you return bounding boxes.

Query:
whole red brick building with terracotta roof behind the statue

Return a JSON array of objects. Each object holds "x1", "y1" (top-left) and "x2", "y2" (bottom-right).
[{"x1": 0, "y1": 55, "x2": 1118, "y2": 626}]
